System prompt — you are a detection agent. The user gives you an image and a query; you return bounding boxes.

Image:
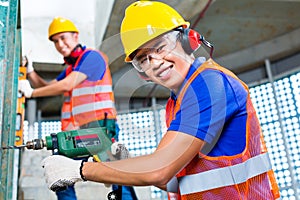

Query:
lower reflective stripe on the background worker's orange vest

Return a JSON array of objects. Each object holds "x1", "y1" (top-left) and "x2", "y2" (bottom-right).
[{"x1": 72, "y1": 101, "x2": 114, "y2": 115}]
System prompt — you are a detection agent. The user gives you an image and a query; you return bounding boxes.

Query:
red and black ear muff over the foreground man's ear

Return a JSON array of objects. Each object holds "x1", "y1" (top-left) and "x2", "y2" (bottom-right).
[{"x1": 181, "y1": 28, "x2": 201, "y2": 55}]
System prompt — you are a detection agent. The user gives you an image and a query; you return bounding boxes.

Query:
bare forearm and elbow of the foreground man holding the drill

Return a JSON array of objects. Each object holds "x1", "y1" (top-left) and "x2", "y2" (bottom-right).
[{"x1": 82, "y1": 131, "x2": 204, "y2": 188}]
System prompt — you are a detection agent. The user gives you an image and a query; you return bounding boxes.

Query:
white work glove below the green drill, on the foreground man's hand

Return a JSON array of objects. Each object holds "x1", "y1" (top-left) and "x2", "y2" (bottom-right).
[{"x1": 42, "y1": 155, "x2": 86, "y2": 192}]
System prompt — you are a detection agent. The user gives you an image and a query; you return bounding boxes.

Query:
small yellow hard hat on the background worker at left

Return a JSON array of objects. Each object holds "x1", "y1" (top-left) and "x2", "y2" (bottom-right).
[{"x1": 48, "y1": 17, "x2": 79, "y2": 40}]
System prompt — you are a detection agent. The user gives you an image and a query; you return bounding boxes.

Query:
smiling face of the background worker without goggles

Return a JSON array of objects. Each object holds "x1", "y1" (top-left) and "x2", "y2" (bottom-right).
[{"x1": 51, "y1": 32, "x2": 78, "y2": 57}]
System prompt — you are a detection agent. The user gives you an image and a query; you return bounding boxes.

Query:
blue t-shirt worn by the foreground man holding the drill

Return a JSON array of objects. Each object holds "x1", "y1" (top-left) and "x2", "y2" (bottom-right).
[{"x1": 168, "y1": 59, "x2": 248, "y2": 156}]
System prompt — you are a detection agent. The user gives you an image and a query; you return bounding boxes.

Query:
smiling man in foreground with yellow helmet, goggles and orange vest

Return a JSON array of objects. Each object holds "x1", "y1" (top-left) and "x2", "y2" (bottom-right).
[{"x1": 42, "y1": 1, "x2": 279, "y2": 199}]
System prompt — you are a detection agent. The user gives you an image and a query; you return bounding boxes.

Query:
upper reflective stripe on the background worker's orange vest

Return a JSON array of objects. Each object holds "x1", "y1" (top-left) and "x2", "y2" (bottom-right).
[{"x1": 72, "y1": 85, "x2": 112, "y2": 97}]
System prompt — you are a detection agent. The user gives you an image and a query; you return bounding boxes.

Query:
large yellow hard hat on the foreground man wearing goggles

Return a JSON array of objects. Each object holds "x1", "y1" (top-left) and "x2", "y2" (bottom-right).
[{"x1": 120, "y1": 1, "x2": 190, "y2": 62}]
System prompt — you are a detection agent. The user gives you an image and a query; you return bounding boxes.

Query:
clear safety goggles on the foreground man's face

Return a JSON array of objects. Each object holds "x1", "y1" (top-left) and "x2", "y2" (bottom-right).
[{"x1": 131, "y1": 31, "x2": 180, "y2": 72}]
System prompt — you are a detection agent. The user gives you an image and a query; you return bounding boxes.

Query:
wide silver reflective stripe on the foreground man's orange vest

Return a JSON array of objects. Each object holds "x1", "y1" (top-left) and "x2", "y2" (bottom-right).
[{"x1": 179, "y1": 153, "x2": 272, "y2": 195}]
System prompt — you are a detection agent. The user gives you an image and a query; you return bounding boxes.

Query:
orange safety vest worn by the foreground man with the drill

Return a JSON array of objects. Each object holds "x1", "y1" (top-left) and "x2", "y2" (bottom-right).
[{"x1": 166, "y1": 59, "x2": 280, "y2": 200}]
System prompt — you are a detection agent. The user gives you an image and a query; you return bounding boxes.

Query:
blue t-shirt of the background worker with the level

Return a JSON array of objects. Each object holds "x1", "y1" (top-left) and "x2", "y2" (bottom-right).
[{"x1": 56, "y1": 50, "x2": 106, "y2": 81}]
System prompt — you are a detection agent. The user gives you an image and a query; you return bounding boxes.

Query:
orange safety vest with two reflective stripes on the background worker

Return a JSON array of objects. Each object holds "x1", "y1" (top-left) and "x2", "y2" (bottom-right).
[{"x1": 61, "y1": 49, "x2": 117, "y2": 130}]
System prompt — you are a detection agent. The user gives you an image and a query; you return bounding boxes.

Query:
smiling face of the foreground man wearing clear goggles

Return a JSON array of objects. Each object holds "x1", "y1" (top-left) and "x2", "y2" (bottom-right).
[{"x1": 132, "y1": 31, "x2": 192, "y2": 92}]
